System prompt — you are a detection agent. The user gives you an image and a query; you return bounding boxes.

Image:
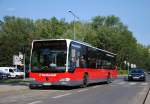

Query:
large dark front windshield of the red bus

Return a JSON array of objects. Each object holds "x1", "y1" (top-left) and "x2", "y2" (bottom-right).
[{"x1": 31, "y1": 40, "x2": 67, "y2": 72}]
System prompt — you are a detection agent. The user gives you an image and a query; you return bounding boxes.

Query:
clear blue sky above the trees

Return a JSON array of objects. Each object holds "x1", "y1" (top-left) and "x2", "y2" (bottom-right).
[{"x1": 0, "y1": 0, "x2": 150, "y2": 45}]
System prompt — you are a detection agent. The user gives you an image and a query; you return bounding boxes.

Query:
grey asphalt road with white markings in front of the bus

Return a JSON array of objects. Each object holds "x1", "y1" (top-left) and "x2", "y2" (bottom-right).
[{"x1": 0, "y1": 77, "x2": 150, "y2": 104}]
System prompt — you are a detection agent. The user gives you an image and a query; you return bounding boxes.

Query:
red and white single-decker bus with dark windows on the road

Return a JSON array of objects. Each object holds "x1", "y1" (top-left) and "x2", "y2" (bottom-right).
[{"x1": 29, "y1": 39, "x2": 118, "y2": 88}]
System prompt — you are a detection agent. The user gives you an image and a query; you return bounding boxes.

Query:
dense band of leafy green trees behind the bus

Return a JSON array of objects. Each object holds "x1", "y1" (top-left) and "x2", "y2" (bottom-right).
[{"x1": 0, "y1": 15, "x2": 150, "y2": 70}]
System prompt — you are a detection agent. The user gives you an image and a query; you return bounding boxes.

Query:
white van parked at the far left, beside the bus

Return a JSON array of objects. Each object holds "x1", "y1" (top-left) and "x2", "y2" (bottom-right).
[{"x1": 0, "y1": 67, "x2": 24, "y2": 78}]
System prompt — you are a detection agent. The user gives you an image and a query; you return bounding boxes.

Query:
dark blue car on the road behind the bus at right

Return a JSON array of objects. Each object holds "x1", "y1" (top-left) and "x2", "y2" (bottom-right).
[{"x1": 128, "y1": 68, "x2": 146, "y2": 81}]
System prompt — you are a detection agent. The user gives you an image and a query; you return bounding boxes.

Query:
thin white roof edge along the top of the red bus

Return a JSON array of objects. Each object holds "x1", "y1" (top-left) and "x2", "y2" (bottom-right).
[{"x1": 32, "y1": 39, "x2": 117, "y2": 56}]
